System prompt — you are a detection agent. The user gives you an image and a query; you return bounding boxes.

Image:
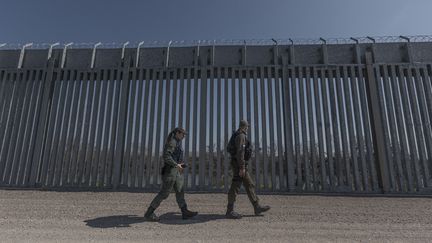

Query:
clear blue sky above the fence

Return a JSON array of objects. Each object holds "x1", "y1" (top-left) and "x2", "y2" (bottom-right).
[{"x1": 0, "y1": 0, "x2": 432, "y2": 43}]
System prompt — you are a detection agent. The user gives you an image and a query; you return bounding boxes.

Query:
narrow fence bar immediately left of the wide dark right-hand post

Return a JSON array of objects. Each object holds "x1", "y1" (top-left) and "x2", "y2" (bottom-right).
[{"x1": 350, "y1": 66, "x2": 371, "y2": 191}]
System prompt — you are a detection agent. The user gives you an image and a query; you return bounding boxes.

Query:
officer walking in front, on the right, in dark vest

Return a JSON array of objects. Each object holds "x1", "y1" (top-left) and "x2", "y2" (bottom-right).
[{"x1": 226, "y1": 120, "x2": 270, "y2": 219}]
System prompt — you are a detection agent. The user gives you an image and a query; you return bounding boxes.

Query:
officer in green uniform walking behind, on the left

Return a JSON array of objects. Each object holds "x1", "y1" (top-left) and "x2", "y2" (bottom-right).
[{"x1": 144, "y1": 127, "x2": 198, "y2": 221}]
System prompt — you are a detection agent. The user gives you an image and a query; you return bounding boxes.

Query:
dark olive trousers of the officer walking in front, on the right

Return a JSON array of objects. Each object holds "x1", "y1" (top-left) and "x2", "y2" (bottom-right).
[{"x1": 228, "y1": 160, "x2": 258, "y2": 205}]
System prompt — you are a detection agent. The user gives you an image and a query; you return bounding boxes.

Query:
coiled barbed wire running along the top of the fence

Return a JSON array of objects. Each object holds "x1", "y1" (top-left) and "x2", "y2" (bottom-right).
[{"x1": 0, "y1": 35, "x2": 432, "y2": 50}]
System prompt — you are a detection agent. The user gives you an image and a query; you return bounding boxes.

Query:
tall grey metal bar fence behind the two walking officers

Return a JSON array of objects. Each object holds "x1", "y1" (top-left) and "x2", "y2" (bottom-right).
[{"x1": 0, "y1": 38, "x2": 432, "y2": 193}]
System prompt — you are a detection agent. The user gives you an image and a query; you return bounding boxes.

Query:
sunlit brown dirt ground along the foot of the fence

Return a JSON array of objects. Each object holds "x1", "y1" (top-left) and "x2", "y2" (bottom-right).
[{"x1": 0, "y1": 189, "x2": 432, "y2": 242}]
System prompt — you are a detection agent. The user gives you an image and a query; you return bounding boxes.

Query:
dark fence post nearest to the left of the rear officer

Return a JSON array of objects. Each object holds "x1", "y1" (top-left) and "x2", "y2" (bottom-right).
[{"x1": 112, "y1": 55, "x2": 131, "y2": 189}]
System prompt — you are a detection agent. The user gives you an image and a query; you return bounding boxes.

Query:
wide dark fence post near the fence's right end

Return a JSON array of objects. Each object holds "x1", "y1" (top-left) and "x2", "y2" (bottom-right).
[{"x1": 365, "y1": 51, "x2": 390, "y2": 193}]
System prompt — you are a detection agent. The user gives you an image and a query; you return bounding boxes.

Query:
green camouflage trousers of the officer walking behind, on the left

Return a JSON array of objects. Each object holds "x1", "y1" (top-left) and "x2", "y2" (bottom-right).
[{"x1": 150, "y1": 168, "x2": 186, "y2": 209}]
